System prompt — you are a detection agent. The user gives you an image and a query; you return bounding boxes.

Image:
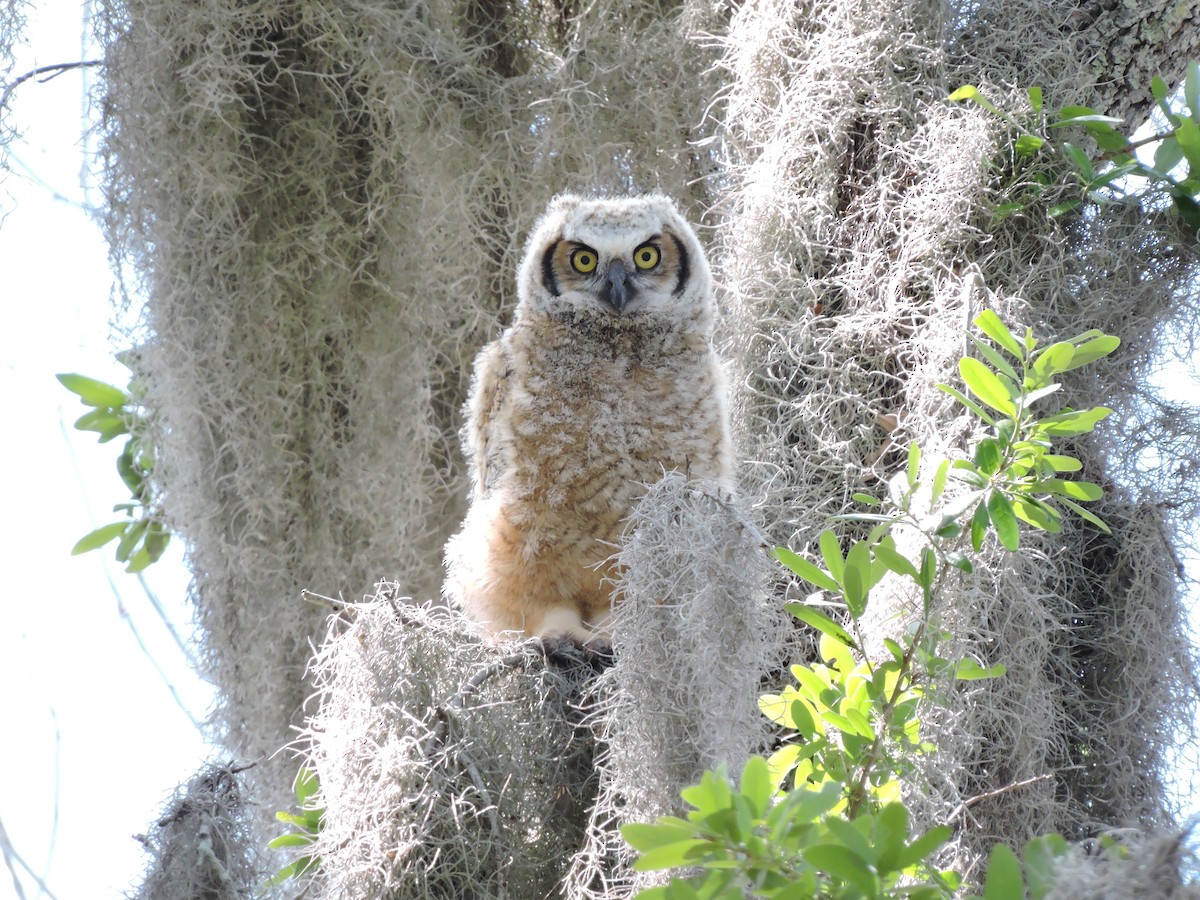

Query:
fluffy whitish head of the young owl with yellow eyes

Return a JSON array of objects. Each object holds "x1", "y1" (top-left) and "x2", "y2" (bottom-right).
[{"x1": 517, "y1": 194, "x2": 715, "y2": 334}]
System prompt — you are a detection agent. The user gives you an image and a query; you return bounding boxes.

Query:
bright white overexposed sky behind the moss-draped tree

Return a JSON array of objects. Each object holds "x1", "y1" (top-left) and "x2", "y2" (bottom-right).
[{"x1": 0, "y1": 0, "x2": 1200, "y2": 900}]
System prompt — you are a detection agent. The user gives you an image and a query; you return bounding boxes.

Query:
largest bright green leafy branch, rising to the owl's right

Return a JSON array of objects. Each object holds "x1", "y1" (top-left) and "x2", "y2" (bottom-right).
[{"x1": 622, "y1": 310, "x2": 1120, "y2": 900}]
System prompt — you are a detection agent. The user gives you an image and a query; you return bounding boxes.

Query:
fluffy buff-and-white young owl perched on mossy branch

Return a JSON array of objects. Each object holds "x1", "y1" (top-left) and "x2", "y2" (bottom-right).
[{"x1": 444, "y1": 194, "x2": 733, "y2": 647}]
